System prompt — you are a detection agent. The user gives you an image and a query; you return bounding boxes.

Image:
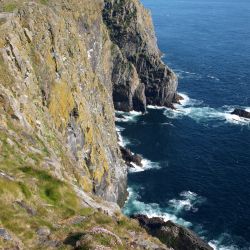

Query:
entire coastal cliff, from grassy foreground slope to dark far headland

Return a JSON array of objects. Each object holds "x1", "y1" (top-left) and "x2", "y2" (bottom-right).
[{"x1": 0, "y1": 0, "x2": 211, "y2": 250}]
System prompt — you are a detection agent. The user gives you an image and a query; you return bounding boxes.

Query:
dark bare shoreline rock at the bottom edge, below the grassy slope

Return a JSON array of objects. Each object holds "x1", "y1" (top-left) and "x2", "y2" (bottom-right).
[{"x1": 132, "y1": 215, "x2": 213, "y2": 250}]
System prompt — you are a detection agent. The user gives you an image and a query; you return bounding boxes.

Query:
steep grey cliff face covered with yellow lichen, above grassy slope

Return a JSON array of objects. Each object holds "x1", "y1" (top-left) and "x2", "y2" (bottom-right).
[{"x1": 0, "y1": 1, "x2": 126, "y2": 205}]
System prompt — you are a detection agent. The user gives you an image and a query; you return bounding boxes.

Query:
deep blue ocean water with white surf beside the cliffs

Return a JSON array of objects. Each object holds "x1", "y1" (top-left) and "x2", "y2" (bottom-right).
[{"x1": 117, "y1": 0, "x2": 250, "y2": 249}]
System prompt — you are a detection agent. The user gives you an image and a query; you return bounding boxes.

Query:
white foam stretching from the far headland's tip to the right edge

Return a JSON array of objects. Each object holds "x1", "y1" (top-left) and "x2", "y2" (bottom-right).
[{"x1": 164, "y1": 94, "x2": 250, "y2": 125}]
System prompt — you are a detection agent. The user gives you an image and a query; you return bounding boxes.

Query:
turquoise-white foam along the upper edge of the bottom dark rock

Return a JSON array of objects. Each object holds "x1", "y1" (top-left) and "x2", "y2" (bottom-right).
[{"x1": 123, "y1": 188, "x2": 192, "y2": 227}]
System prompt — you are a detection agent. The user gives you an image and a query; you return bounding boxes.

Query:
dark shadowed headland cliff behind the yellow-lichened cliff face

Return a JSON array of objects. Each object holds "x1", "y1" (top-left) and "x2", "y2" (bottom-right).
[{"x1": 103, "y1": 0, "x2": 178, "y2": 111}]
